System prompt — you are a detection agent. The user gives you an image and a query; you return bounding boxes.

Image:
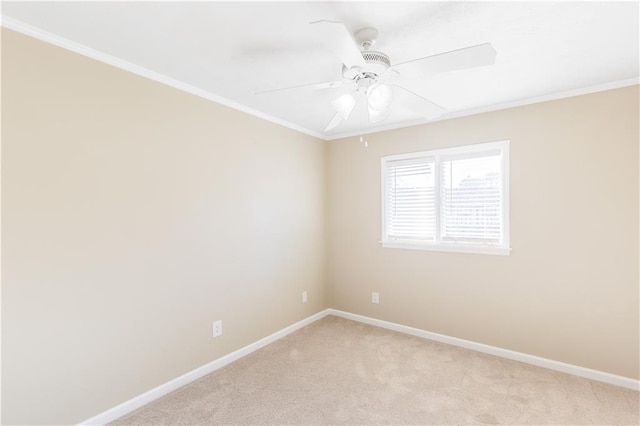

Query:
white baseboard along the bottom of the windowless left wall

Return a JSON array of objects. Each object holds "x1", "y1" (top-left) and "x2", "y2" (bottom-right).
[{"x1": 79, "y1": 309, "x2": 329, "y2": 425}]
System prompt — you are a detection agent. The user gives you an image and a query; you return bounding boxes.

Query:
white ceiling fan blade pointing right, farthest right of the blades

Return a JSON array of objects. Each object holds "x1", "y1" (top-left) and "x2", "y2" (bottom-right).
[{"x1": 393, "y1": 43, "x2": 496, "y2": 77}]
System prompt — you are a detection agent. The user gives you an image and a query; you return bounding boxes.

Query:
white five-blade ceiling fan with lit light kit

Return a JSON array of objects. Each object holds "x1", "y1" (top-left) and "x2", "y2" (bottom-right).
[{"x1": 256, "y1": 21, "x2": 496, "y2": 132}]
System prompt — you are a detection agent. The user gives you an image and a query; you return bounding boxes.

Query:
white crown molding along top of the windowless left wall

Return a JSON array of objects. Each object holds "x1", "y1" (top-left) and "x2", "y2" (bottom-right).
[{"x1": 0, "y1": 15, "x2": 326, "y2": 140}]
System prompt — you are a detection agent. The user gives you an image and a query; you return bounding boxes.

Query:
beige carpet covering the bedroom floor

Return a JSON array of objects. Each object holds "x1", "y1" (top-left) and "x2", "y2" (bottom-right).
[{"x1": 113, "y1": 316, "x2": 640, "y2": 425}]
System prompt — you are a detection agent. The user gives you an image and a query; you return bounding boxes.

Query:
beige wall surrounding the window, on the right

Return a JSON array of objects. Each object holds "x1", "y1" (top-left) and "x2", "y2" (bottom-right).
[{"x1": 327, "y1": 86, "x2": 640, "y2": 379}]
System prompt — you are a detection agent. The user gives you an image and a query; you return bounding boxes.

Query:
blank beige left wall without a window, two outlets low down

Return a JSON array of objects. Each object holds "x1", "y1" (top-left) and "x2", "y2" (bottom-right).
[{"x1": 2, "y1": 30, "x2": 326, "y2": 424}]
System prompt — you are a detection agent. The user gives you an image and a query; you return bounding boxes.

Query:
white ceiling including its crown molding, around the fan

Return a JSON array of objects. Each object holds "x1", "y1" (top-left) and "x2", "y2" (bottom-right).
[{"x1": 2, "y1": 1, "x2": 640, "y2": 139}]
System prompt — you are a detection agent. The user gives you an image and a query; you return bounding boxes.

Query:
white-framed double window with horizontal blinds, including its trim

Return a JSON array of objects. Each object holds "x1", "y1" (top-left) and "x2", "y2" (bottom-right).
[{"x1": 382, "y1": 141, "x2": 510, "y2": 254}]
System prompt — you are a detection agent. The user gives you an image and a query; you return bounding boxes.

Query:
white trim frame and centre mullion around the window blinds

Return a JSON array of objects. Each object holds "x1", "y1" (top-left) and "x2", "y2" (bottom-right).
[{"x1": 379, "y1": 140, "x2": 511, "y2": 255}]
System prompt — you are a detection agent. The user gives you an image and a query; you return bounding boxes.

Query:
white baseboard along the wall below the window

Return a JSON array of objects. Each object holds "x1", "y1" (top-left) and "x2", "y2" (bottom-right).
[{"x1": 328, "y1": 309, "x2": 640, "y2": 391}]
